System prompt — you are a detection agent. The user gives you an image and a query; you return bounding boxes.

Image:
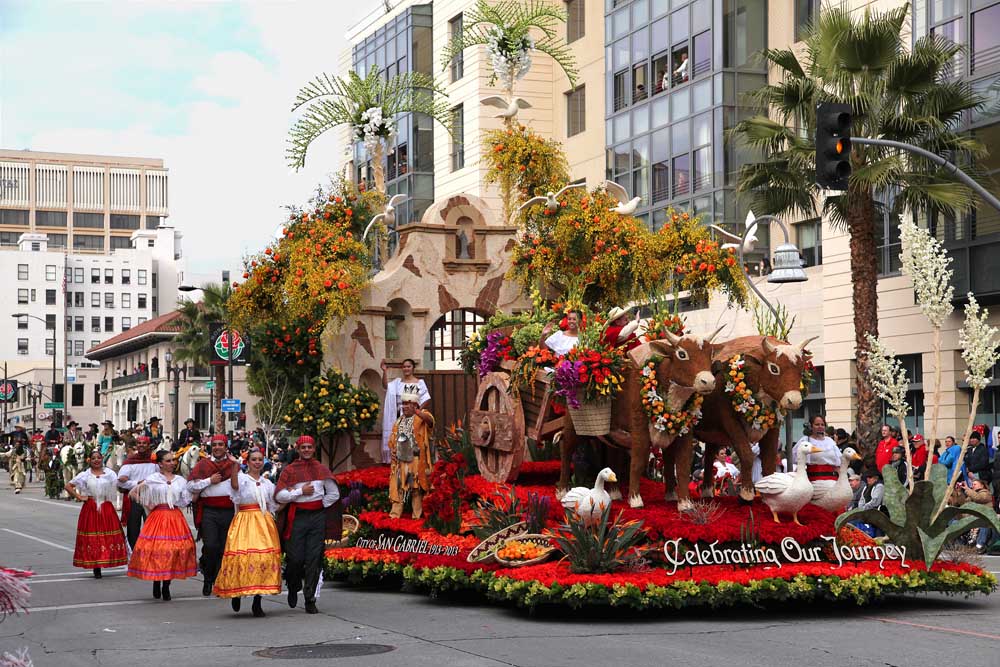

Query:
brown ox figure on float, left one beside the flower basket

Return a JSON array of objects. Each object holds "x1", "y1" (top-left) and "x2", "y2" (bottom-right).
[{"x1": 556, "y1": 327, "x2": 721, "y2": 507}]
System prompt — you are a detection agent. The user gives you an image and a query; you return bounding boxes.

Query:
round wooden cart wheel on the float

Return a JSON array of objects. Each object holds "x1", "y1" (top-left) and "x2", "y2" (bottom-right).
[{"x1": 469, "y1": 373, "x2": 527, "y2": 484}]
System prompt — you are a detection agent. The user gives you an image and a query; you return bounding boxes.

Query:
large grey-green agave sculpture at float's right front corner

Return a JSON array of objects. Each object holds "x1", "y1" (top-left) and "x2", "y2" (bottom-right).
[{"x1": 834, "y1": 463, "x2": 1000, "y2": 568}]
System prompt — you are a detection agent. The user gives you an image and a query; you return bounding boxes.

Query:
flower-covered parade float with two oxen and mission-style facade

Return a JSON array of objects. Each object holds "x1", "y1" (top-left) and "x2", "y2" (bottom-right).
[{"x1": 266, "y1": 0, "x2": 1000, "y2": 610}]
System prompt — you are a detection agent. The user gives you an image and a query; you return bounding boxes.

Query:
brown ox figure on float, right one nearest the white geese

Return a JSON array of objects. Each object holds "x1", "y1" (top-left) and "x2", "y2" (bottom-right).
[{"x1": 663, "y1": 336, "x2": 815, "y2": 510}]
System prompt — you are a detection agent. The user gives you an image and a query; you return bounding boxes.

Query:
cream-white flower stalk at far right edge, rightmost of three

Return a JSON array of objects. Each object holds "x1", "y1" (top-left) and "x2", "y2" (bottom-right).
[{"x1": 928, "y1": 292, "x2": 1000, "y2": 519}]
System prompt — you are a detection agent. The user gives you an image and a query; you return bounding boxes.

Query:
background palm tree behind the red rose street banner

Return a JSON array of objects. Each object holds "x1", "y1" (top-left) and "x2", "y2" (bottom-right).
[{"x1": 174, "y1": 283, "x2": 232, "y2": 437}]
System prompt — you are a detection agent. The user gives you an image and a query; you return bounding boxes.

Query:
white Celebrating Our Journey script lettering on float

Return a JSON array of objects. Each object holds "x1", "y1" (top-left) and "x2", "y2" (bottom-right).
[{"x1": 663, "y1": 535, "x2": 910, "y2": 574}]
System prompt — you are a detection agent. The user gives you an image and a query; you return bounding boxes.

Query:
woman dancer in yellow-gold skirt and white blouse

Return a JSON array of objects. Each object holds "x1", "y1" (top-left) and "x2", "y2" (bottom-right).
[{"x1": 215, "y1": 449, "x2": 281, "y2": 618}]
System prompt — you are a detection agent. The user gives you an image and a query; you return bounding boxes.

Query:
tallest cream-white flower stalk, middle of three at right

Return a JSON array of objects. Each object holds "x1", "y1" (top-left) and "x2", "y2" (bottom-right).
[{"x1": 899, "y1": 216, "x2": 955, "y2": 480}]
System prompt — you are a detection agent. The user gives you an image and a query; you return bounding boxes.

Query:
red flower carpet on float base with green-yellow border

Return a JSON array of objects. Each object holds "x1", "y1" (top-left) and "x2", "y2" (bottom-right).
[{"x1": 326, "y1": 461, "x2": 996, "y2": 609}]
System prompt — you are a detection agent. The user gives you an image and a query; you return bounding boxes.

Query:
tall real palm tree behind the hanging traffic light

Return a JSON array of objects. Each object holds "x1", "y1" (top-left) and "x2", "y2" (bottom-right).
[{"x1": 732, "y1": 6, "x2": 986, "y2": 462}]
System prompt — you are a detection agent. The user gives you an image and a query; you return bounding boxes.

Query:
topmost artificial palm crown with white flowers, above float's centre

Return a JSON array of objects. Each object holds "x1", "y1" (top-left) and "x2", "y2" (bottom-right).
[{"x1": 441, "y1": 0, "x2": 577, "y2": 99}]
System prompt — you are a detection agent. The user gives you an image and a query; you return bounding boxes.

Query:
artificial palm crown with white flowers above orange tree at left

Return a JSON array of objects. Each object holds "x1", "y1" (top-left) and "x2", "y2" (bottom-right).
[{"x1": 287, "y1": 67, "x2": 451, "y2": 193}]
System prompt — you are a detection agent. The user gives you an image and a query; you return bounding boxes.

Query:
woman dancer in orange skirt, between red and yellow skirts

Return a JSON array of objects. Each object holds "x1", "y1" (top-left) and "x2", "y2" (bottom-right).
[{"x1": 128, "y1": 450, "x2": 198, "y2": 600}]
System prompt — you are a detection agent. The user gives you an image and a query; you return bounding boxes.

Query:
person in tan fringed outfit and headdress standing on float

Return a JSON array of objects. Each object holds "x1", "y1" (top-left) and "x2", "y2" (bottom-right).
[{"x1": 389, "y1": 393, "x2": 434, "y2": 519}]
